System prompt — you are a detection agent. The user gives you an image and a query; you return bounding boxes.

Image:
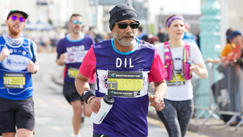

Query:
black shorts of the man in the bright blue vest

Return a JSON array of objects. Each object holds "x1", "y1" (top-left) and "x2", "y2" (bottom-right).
[{"x1": 0, "y1": 97, "x2": 35, "y2": 134}]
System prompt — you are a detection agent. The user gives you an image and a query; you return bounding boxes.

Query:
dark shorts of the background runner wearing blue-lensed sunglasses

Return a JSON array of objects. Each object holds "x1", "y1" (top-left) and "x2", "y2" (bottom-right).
[{"x1": 63, "y1": 82, "x2": 95, "y2": 103}]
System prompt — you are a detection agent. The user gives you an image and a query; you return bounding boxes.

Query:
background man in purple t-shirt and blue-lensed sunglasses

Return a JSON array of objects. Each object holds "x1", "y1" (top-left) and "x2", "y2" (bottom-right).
[{"x1": 56, "y1": 14, "x2": 94, "y2": 137}]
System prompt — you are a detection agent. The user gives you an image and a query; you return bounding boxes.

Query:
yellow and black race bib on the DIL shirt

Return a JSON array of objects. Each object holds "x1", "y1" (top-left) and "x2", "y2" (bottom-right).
[{"x1": 107, "y1": 71, "x2": 143, "y2": 97}]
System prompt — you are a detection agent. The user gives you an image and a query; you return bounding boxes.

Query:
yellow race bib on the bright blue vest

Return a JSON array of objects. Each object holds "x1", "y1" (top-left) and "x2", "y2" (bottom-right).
[{"x1": 3, "y1": 73, "x2": 25, "y2": 88}]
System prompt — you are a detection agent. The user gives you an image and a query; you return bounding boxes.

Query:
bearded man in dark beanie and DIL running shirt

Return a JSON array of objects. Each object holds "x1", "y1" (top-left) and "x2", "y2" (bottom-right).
[{"x1": 75, "y1": 5, "x2": 166, "y2": 137}]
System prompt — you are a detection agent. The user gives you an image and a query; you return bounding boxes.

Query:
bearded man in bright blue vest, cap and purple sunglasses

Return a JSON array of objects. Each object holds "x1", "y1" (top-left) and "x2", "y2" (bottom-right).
[{"x1": 0, "y1": 10, "x2": 39, "y2": 137}]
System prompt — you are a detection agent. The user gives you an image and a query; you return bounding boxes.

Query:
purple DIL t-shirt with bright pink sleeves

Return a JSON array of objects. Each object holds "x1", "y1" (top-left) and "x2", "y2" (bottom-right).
[{"x1": 80, "y1": 40, "x2": 166, "y2": 137}]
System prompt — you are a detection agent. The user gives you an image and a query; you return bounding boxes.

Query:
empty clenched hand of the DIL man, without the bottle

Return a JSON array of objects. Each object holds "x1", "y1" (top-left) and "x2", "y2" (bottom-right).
[{"x1": 149, "y1": 95, "x2": 165, "y2": 111}]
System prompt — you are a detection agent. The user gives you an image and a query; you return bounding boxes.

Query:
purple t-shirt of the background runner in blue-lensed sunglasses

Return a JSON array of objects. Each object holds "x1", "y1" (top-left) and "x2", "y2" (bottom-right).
[{"x1": 57, "y1": 35, "x2": 94, "y2": 82}]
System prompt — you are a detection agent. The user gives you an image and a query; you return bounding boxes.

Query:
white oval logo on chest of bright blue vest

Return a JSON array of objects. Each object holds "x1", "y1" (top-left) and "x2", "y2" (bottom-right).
[{"x1": 2, "y1": 55, "x2": 28, "y2": 71}]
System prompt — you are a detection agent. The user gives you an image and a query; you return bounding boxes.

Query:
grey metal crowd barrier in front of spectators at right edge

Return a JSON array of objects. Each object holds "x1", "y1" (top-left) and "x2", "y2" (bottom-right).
[{"x1": 195, "y1": 63, "x2": 243, "y2": 130}]
